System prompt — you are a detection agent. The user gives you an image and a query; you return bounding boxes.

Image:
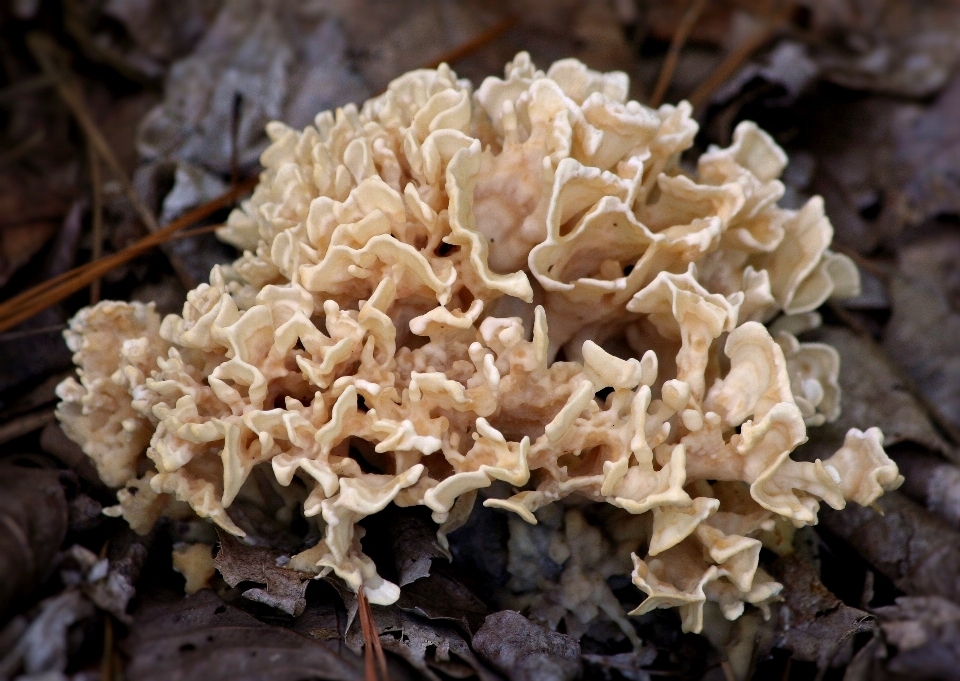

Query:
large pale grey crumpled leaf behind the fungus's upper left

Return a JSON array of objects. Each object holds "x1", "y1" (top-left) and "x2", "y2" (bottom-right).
[{"x1": 138, "y1": 0, "x2": 369, "y2": 174}]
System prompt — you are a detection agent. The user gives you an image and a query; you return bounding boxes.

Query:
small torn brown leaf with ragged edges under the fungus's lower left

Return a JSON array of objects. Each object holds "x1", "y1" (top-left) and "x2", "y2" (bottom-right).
[{"x1": 214, "y1": 528, "x2": 310, "y2": 617}]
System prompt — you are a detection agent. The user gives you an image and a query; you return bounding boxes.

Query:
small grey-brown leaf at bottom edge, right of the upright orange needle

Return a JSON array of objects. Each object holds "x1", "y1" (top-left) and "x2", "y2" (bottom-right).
[{"x1": 473, "y1": 610, "x2": 581, "y2": 681}]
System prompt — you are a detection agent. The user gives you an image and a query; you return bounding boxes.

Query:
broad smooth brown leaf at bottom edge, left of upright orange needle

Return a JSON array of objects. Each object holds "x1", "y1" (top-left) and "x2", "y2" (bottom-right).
[{"x1": 121, "y1": 589, "x2": 363, "y2": 681}]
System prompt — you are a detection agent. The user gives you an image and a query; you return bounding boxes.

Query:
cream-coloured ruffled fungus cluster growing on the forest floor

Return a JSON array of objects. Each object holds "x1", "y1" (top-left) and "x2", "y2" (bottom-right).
[{"x1": 58, "y1": 53, "x2": 901, "y2": 631}]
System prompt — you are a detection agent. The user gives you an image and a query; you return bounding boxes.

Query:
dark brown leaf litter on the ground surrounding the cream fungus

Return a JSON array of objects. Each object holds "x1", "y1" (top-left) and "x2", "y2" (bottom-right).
[{"x1": 7, "y1": 0, "x2": 960, "y2": 681}]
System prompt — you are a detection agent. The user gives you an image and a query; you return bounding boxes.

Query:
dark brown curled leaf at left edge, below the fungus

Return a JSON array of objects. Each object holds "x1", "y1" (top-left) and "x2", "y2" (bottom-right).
[{"x1": 0, "y1": 463, "x2": 69, "y2": 619}]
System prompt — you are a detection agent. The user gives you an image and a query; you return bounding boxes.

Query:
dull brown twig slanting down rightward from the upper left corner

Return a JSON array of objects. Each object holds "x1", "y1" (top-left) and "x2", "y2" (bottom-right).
[{"x1": 27, "y1": 33, "x2": 196, "y2": 290}]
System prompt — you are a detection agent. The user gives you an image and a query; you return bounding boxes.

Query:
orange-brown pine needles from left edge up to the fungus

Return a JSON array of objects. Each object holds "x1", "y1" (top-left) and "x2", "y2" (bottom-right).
[{"x1": 0, "y1": 177, "x2": 259, "y2": 333}]
